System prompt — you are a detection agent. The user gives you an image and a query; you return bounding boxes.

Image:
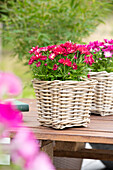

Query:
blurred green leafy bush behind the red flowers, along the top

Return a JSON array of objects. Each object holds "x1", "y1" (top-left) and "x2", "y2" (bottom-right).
[{"x1": 1, "y1": 0, "x2": 112, "y2": 59}]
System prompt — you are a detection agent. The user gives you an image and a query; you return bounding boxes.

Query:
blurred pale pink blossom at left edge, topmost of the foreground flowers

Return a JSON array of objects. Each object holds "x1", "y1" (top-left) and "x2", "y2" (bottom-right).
[{"x1": 0, "y1": 72, "x2": 22, "y2": 96}]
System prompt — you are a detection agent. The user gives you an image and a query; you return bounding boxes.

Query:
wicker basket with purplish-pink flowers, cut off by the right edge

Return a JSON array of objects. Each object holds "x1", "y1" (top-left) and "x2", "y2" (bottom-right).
[{"x1": 87, "y1": 39, "x2": 113, "y2": 116}]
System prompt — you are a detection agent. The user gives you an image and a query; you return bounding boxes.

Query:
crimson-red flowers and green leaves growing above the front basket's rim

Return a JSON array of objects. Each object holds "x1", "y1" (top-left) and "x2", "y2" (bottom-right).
[{"x1": 29, "y1": 41, "x2": 94, "y2": 81}]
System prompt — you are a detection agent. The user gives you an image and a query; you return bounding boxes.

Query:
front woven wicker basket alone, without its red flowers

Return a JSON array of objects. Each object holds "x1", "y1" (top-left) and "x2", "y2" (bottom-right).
[{"x1": 33, "y1": 79, "x2": 96, "y2": 129}]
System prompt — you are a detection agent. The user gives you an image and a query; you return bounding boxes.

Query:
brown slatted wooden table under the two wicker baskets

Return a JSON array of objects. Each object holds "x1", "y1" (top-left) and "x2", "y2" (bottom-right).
[{"x1": 16, "y1": 99, "x2": 113, "y2": 169}]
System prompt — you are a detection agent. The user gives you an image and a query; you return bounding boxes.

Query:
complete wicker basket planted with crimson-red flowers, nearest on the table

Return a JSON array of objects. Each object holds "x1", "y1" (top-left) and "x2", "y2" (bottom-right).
[{"x1": 29, "y1": 42, "x2": 96, "y2": 129}]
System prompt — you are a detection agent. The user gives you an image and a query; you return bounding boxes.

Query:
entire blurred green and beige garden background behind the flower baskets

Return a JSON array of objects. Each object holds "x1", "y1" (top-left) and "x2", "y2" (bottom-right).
[{"x1": 0, "y1": 0, "x2": 113, "y2": 98}]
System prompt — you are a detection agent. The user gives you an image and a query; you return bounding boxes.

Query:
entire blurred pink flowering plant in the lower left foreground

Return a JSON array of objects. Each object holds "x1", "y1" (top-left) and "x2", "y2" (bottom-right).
[{"x1": 0, "y1": 72, "x2": 55, "y2": 170}]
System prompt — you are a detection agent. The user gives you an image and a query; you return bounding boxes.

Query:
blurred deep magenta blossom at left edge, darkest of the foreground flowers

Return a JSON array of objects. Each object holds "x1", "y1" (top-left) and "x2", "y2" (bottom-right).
[{"x1": 0, "y1": 102, "x2": 23, "y2": 129}]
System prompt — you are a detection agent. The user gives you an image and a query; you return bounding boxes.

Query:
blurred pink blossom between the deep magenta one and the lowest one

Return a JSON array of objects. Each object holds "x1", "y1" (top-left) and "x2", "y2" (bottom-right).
[{"x1": 11, "y1": 127, "x2": 39, "y2": 164}]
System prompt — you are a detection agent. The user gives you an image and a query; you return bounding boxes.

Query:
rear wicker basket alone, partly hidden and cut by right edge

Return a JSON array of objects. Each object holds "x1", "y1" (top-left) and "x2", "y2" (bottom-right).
[{"x1": 90, "y1": 71, "x2": 113, "y2": 116}]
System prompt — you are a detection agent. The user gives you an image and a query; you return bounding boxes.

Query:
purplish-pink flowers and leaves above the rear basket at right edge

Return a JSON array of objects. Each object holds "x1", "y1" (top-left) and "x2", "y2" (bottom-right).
[{"x1": 86, "y1": 39, "x2": 113, "y2": 72}]
